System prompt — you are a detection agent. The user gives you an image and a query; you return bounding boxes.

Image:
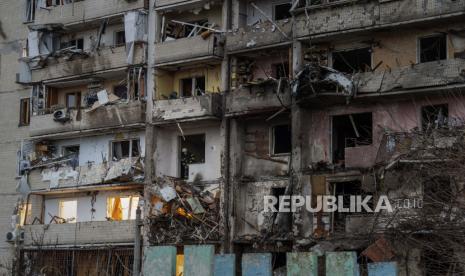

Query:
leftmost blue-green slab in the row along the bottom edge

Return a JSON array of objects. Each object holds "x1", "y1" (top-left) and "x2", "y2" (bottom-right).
[{"x1": 142, "y1": 246, "x2": 176, "y2": 276}]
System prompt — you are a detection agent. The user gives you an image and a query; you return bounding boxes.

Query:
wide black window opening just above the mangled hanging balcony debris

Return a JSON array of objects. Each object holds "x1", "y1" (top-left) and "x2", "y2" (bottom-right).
[{"x1": 332, "y1": 48, "x2": 371, "y2": 74}]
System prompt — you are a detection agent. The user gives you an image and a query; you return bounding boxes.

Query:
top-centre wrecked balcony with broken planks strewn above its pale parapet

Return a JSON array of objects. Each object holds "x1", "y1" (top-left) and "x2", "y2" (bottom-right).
[{"x1": 154, "y1": 4, "x2": 224, "y2": 69}]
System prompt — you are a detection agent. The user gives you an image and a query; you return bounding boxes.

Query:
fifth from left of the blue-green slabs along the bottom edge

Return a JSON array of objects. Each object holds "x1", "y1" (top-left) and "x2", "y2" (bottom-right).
[{"x1": 286, "y1": 252, "x2": 318, "y2": 276}]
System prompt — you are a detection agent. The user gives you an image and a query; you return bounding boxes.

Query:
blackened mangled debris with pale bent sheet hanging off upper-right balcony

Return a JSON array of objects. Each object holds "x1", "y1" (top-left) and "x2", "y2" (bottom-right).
[{"x1": 292, "y1": 63, "x2": 355, "y2": 97}]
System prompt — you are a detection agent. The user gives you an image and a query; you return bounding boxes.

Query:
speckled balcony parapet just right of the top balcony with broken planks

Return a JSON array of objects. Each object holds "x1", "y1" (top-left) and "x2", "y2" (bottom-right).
[{"x1": 226, "y1": 20, "x2": 292, "y2": 53}]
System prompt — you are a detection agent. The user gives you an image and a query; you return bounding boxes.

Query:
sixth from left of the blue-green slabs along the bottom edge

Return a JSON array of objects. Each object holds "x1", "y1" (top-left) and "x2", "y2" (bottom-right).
[{"x1": 326, "y1": 251, "x2": 359, "y2": 276}]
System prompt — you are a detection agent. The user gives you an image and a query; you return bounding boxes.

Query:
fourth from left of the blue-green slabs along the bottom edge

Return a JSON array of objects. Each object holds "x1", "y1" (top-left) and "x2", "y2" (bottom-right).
[{"x1": 242, "y1": 253, "x2": 273, "y2": 276}]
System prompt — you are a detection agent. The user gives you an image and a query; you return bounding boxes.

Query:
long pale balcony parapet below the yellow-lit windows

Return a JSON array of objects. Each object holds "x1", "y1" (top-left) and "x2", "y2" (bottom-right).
[{"x1": 24, "y1": 220, "x2": 134, "y2": 246}]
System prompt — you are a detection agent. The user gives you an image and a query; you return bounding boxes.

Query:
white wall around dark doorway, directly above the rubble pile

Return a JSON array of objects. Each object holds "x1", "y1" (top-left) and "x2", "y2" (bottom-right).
[{"x1": 155, "y1": 123, "x2": 223, "y2": 181}]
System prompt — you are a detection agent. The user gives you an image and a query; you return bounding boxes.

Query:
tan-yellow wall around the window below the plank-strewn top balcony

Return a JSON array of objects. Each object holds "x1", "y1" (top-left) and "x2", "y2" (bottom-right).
[{"x1": 155, "y1": 65, "x2": 221, "y2": 100}]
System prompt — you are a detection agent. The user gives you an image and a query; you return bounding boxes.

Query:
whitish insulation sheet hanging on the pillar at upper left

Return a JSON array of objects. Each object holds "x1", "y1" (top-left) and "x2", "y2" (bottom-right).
[{"x1": 124, "y1": 11, "x2": 147, "y2": 64}]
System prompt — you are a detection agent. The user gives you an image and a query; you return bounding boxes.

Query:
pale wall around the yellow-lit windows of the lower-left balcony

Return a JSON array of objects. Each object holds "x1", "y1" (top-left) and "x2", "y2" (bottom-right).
[{"x1": 42, "y1": 190, "x2": 140, "y2": 224}]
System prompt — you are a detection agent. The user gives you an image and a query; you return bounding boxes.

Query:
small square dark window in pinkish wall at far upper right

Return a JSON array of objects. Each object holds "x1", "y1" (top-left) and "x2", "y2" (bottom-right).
[{"x1": 419, "y1": 34, "x2": 447, "y2": 62}]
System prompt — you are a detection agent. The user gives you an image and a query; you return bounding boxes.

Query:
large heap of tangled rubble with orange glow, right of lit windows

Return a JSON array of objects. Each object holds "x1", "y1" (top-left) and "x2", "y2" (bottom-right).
[{"x1": 147, "y1": 178, "x2": 222, "y2": 244}]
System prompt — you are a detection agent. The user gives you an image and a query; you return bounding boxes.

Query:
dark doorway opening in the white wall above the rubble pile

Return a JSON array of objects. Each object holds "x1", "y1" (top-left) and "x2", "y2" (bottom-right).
[{"x1": 179, "y1": 134, "x2": 205, "y2": 179}]
